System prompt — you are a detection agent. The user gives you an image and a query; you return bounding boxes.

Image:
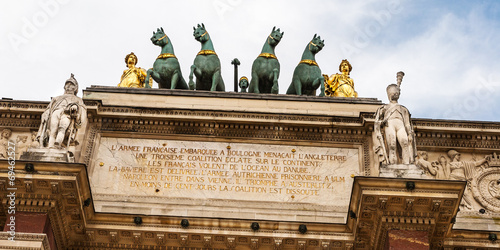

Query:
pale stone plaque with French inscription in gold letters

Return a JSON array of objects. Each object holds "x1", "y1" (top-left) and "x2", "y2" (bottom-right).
[{"x1": 90, "y1": 137, "x2": 361, "y2": 223}]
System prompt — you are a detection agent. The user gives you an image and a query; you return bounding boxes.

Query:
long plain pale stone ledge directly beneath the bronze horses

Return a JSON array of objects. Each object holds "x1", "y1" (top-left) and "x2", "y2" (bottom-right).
[{"x1": 83, "y1": 86, "x2": 381, "y2": 118}]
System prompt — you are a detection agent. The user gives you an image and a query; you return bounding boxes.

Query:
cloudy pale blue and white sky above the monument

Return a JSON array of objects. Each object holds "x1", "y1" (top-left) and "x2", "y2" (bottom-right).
[{"x1": 0, "y1": 0, "x2": 500, "y2": 121}]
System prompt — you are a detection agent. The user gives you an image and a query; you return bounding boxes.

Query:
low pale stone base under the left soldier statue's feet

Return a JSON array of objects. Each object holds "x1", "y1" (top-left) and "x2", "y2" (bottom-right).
[{"x1": 21, "y1": 148, "x2": 75, "y2": 162}]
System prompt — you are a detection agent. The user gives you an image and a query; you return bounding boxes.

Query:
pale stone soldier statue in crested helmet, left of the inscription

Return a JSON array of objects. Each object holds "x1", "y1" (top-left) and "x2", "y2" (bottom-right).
[{"x1": 36, "y1": 74, "x2": 87, "y2": 149}]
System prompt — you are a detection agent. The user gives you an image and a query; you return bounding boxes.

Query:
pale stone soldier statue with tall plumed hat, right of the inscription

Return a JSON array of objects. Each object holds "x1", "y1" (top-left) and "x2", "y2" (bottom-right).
[{"x1": 374, "y1": 72, "x2": 416, "y2": 165}]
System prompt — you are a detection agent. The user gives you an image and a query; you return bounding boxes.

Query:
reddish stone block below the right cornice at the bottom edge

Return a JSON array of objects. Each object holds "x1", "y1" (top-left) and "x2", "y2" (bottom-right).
[{"x1": 385, "y1": 230, "x2": 430, "y2": 250}]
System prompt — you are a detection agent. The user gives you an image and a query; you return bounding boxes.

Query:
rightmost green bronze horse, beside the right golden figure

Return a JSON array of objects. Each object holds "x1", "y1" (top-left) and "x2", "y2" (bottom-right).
[{"x1": 286, "y1": 34, "x2": 325, "y2": 96}]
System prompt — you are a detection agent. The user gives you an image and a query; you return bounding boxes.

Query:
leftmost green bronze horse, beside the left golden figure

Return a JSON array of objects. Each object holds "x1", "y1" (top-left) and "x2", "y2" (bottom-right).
[{"x1": 145, "y1": 28, "x2": 188, "y2": 89}]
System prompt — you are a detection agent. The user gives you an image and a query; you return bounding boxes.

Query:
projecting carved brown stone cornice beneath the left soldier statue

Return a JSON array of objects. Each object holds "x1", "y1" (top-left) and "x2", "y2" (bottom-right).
[{"x1": 0, "y1": 160, "x2": 90, "y2": 248}]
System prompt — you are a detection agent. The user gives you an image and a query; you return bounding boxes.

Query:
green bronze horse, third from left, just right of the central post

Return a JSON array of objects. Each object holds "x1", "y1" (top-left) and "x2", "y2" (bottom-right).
[{"x1": 248, "y1": 27, "x2": 285, "y2": 94}]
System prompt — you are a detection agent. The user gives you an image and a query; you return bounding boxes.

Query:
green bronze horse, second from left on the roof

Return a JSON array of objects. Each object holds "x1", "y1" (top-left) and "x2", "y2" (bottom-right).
[{"x1": 189, "y1": 23, "x2": 225, "y2": 91}]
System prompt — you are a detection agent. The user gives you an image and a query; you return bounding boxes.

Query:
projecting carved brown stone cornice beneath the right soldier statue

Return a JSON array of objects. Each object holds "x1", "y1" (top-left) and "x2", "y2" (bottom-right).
[{"x1": 347, "y1": 177, "x2": 465, "y2": 249}]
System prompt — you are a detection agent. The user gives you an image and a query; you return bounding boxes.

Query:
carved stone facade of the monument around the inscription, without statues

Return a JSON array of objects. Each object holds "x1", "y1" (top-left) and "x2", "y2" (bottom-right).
[{"x1": 0, "y1": 87, "x2": 500, "y2": 249}]
